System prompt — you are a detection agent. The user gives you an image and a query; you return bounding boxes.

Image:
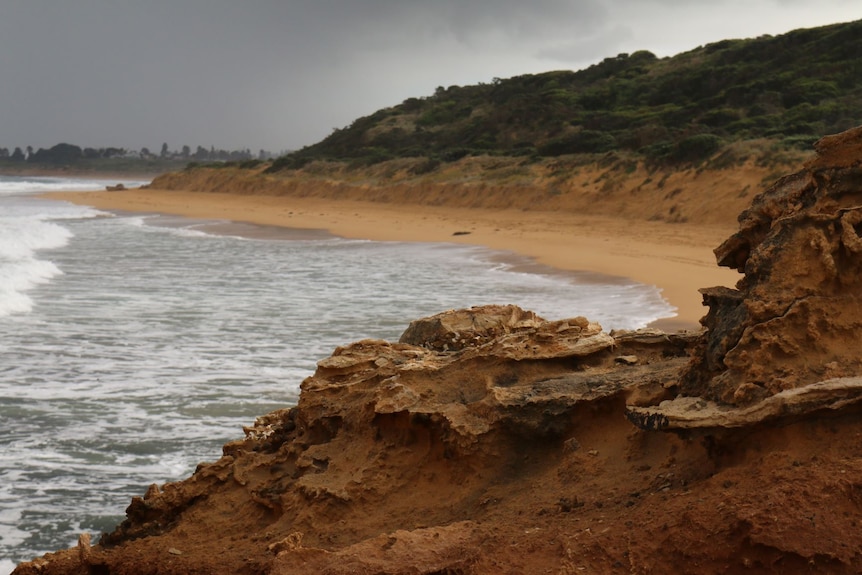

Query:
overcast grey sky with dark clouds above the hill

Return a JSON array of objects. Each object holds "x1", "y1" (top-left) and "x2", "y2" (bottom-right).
[{"x1": 0, "y1": 0, "x2": 862, "y2": 155}]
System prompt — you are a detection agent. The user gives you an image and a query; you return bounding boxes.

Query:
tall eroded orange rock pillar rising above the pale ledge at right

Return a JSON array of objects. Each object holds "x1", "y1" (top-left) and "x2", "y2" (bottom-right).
[{"x1": 682, "y1": 129, "x2": 862, "y2": 406}]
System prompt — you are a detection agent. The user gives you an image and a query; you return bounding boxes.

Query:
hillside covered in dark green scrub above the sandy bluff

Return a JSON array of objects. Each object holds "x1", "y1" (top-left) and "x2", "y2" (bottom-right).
[{"x1": 270, "y1": 21, "x2": 862, "y2": 171}]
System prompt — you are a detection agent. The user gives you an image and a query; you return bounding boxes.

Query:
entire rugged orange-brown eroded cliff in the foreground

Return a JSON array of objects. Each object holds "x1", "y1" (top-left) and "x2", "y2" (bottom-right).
[{"x1": 15, "y1": 129, "x2": 862, "y2": 575}]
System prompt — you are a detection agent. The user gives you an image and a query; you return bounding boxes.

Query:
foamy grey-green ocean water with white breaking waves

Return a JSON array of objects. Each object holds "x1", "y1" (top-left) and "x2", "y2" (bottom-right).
[{"x1": 0, "y1": 176, "x2": 673, "y2": 573}]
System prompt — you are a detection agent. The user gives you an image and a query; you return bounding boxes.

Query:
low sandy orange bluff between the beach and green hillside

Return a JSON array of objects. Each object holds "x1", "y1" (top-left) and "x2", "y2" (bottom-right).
[{"x1": 149, "y1": 152, "x2": 810, "y2": 225}]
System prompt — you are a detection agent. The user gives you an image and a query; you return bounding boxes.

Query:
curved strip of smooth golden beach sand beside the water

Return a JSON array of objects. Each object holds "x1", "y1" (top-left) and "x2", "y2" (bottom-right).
[{"x1": 46, "y1": 189, "x2": 739, "y2": 331}]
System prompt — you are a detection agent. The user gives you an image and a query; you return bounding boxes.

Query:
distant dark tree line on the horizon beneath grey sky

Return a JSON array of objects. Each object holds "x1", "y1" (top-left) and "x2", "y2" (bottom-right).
[{"x1": 0, "y1": 143, "x2": 276, "y2": 164}]
